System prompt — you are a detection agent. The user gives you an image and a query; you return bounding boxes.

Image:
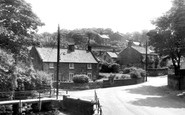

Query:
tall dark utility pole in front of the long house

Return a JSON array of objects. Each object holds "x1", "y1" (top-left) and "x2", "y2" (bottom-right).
[{"x1": 56, "y1": 25, "x2": 60, "y2": 99}]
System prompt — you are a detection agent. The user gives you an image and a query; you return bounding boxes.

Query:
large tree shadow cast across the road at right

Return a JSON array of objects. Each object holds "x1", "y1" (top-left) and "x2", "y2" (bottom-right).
[{"x1": 125, "y1": 86, "x2": 185, "y2": 108}]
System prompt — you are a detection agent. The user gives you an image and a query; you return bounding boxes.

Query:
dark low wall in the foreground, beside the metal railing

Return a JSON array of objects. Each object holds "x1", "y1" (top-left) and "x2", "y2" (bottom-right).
[{"x1": 63, "y1": 96, "x2": 94, "y2": 115}]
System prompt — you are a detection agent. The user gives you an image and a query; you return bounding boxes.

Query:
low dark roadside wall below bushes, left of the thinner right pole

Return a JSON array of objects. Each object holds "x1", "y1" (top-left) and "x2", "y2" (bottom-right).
[{"x1": 103, "y1": 78, "x2": 144, "y2": 88}]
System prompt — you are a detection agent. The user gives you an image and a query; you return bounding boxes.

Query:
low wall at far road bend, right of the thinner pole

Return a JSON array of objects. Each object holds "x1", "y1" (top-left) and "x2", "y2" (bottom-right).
[{"x1": 147, "y1": 68, "x2": 168, "y2": 76}]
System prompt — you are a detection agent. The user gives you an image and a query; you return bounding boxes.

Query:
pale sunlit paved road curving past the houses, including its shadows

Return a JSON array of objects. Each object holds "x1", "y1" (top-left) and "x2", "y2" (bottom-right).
[{"x1": 70, "y1": 76, "x2": 185, "y2": 115}]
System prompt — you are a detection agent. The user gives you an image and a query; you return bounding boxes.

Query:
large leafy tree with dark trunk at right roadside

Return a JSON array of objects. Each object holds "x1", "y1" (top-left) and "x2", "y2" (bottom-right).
[{"x1": 148, "y1": 0, "x2": 185, "y2": 75}]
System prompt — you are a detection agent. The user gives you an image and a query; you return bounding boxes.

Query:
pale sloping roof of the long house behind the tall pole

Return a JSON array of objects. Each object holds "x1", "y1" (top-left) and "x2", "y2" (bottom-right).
[{"x1": 36, "y1": 47, "x2": 98, "y2": 63}]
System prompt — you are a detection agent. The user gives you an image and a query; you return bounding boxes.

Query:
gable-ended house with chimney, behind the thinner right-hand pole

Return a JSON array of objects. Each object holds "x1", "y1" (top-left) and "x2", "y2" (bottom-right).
[{"x1": 118, "y1": 41, "x2": 158, "y2": 68}]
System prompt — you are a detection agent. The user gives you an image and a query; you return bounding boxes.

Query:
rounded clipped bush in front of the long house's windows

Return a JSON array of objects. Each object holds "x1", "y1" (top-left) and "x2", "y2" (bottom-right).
[{"x1": 73, "y1": 74, "x2": 89, "y2": 83}]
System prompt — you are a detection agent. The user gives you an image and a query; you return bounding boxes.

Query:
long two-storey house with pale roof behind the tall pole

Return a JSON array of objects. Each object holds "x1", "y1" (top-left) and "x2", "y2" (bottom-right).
[{"x1": 30, "y1": 45, "x2": 98, "y2": 81}]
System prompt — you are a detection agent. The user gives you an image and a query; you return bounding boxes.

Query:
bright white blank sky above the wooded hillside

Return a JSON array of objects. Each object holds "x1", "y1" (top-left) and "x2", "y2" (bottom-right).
[{"x1": 25, "y1": 0, "x2": 172, "y2": 33}]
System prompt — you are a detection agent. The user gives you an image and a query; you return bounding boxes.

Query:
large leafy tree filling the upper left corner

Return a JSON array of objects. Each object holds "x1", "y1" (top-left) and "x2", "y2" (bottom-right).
[{"x1": 0, "y1": 0, "x2": 43, "y2": 56}]
